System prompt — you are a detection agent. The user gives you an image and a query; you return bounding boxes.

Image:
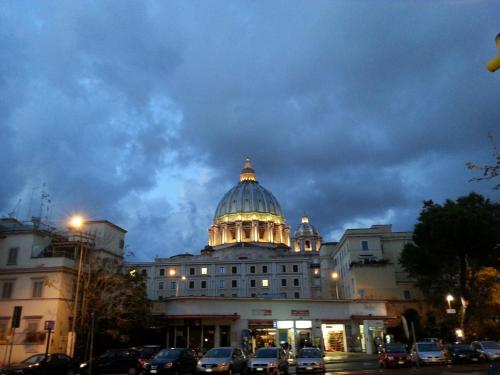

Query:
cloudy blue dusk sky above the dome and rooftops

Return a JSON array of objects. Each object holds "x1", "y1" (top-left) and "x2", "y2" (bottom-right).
[{"x1": 0, "y1": 0, "x2": 500, "y2": 261}]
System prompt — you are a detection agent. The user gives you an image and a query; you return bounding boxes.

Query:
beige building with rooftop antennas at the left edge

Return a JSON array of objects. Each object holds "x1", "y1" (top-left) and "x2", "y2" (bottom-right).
[{"x1": 0, "y1": 218, "x2": 126, "y2": 364}]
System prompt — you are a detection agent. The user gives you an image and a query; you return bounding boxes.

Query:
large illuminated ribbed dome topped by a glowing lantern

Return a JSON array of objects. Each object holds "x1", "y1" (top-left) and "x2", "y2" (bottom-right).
[{"x1": 208, "y1": 158, "x2": 290, "y2": 250}]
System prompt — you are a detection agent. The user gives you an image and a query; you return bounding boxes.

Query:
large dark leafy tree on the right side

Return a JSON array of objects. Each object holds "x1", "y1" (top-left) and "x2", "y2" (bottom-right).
[{"x1": 400, "y1": 193, "x2": 500, "y2": 338}]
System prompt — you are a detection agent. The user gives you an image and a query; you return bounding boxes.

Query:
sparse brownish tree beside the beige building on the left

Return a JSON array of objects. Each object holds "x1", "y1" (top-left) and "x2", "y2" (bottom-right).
[{"x1": 77, "y1": 257, "x2": 151, "y2": 358}]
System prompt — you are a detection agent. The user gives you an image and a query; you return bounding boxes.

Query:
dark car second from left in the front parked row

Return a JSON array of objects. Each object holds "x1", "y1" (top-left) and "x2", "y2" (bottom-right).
[{"x1": 80, "y1": 349, "x2": 143, "y2": 375}]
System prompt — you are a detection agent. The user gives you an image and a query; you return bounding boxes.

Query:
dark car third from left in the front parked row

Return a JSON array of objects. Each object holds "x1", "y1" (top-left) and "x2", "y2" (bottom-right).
[{"x1": 148, "y1": 348, "x2": 198, "y2": 375}]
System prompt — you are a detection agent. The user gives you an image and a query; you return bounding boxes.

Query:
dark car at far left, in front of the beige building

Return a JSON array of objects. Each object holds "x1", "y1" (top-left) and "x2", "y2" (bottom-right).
[{"x1": 0, "y1": 353, "x2": 80, "y2": 375}]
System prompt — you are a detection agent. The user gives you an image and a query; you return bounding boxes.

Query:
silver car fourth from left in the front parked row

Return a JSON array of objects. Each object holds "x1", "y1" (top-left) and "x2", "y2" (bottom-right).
[{"x1": 197, "y1": 347, "x2": 247, "y2": 375}]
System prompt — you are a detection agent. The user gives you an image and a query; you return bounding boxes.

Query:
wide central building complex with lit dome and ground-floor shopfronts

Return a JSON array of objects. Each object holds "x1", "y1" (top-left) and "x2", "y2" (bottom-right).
[{"x1": 129, "y1": 158, "x2": 418, "y2": 353}]
